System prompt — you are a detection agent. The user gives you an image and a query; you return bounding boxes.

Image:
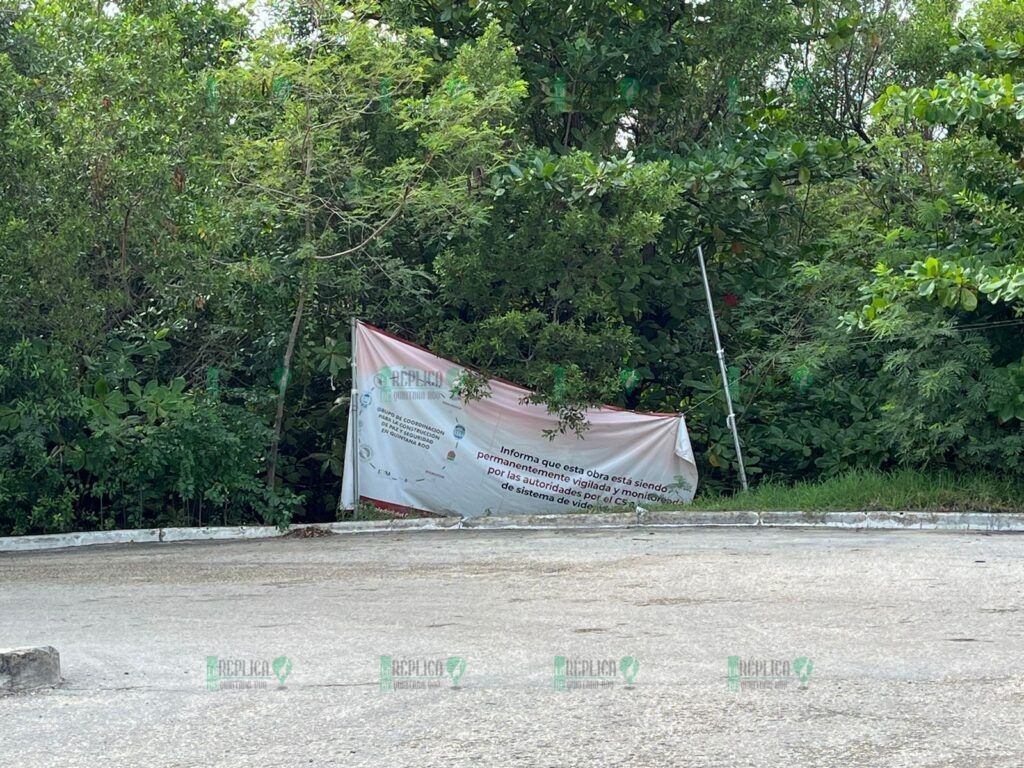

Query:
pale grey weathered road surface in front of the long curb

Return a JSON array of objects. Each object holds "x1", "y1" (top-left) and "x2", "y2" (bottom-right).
[{"x1": 0, "y1": 528, "x2": 1024, "y2": 768}]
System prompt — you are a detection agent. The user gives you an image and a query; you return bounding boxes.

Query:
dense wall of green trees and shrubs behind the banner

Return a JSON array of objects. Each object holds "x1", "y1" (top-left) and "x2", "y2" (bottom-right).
[{"x1": 0, "y1": 0, "x2": 1024, "y2": 535}]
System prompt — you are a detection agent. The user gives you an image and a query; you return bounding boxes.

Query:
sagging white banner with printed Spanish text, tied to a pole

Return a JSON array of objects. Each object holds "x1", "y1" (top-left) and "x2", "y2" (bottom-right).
[{"x1": 342, "y1": 323, "x2": 697, "y2": 517}]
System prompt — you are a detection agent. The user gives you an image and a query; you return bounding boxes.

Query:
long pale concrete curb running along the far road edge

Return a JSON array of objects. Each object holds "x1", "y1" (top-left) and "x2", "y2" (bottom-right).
[{"x1": 0, "y1": 508, "x2": 1024, "y2": 552}]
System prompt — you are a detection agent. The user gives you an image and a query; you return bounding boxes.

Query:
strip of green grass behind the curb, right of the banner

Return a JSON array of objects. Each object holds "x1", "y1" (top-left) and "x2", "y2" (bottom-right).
[{"x1": 652, "y1": 470, "x2": 1024, "y2": 512}]
